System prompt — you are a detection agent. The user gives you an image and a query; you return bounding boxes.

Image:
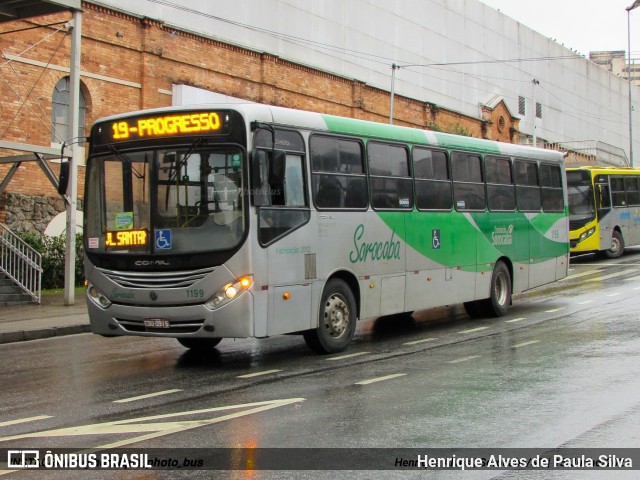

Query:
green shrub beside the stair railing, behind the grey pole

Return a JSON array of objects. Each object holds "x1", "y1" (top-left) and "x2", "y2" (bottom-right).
[{"x1": 18, "y1": 233, "x2": 84, "y2": 289}]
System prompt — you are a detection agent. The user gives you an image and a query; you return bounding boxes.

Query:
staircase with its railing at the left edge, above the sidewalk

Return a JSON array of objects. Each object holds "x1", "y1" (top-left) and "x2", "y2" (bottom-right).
[{"x1": 0, "y1": 223, "x2": 42, "y2": 306}]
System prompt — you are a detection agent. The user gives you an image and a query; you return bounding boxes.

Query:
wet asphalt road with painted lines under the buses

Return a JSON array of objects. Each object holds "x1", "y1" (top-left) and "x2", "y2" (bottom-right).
[{"x1": 0, "y1": 250, "x2": 640, "y2": 479}]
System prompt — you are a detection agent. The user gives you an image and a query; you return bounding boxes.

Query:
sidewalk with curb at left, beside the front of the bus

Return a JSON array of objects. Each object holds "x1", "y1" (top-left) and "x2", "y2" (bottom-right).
[{"x1": 0, "y1": 293, "x2": 91, "y2": 344}]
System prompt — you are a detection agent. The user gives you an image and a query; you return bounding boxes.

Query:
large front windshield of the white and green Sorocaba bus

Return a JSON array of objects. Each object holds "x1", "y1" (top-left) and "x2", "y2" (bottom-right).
[{"x1": 85, "y1": 142, "x2": 245, "y2": 254}]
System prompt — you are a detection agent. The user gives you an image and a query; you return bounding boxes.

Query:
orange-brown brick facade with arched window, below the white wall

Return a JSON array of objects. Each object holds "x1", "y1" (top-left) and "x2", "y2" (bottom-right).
[{"x1": 0, "y1": 2, "x2": 519, "y2": 231}]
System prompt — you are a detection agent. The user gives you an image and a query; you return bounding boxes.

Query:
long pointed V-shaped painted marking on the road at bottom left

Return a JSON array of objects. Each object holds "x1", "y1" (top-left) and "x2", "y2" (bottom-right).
[{"x1": 0, "y1": 398, "x2": 305, "y2": 449}]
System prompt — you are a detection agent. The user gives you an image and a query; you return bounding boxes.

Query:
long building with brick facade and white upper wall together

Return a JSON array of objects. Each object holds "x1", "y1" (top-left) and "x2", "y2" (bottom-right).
[{"x1": 0, "y1": 0, "x2": 640, "y2": 231}]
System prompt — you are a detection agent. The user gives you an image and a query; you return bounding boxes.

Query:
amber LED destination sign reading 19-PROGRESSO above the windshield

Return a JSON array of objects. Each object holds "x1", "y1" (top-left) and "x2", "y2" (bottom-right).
[{"x1": 111, "y1": 112, "x2": 222, "y2": 141}]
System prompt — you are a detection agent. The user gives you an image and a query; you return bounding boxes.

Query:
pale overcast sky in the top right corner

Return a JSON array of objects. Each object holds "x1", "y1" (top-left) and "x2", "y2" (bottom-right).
[{"x1": 480, "y1": 0, "x2": 640, "y2": 59}]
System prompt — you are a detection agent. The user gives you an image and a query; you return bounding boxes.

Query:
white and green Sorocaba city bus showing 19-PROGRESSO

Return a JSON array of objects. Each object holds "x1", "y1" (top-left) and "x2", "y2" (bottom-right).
[{"x1": 84, "y1": 104, "x2": 569, "y2": 353}]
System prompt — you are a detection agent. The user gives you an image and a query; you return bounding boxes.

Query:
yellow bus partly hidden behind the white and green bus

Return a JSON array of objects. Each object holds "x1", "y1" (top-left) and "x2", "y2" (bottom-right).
[{"x1": 566, "y1": 166, "x2": 640, "y2": 258}]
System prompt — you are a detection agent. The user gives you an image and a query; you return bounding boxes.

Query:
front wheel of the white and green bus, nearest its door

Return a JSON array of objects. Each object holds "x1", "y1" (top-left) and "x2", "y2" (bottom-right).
[{"x1": 302, "y1": 278, "x2": 357, "y2": 354}]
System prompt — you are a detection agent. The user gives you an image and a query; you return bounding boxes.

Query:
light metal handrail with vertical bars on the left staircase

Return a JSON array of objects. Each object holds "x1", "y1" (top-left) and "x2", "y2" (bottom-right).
[{"x1": 0, "y1": 223, "x2": 42, "y2": 303}]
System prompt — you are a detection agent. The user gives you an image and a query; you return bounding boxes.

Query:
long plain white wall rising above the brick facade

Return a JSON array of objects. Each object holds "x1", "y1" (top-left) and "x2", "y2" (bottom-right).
[{"x1": 93, "y1": 0, "x2": 640, "y2": 164}]
